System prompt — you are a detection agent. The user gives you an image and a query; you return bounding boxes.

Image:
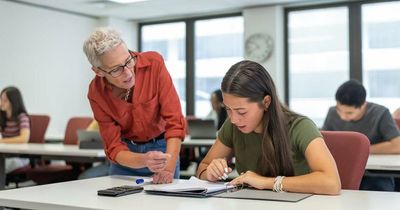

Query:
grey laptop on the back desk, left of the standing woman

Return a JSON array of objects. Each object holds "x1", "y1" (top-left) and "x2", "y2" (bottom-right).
[{"x1": 78, "y1": 130, "x2": 103, "y2": 149}]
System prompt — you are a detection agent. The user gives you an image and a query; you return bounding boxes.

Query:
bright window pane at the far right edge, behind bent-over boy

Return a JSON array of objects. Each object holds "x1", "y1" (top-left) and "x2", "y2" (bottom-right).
[{"x1": 362, "y1": 2, "x2": 400, "y2": 111}]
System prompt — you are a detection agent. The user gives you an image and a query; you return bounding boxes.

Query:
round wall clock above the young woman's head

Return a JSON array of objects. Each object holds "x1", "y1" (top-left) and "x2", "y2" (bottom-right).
[{"x1": 245, "y1": 33, "x2": 273, "y2": 63}]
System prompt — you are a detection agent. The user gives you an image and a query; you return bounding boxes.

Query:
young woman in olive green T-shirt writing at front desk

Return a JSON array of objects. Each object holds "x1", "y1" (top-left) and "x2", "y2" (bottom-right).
[{"x1": 197, "y1": 61, "x2": 341, "y2": 195}]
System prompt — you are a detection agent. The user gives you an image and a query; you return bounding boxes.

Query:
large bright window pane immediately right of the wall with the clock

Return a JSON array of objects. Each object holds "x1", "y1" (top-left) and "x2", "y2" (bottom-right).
[{"x1": 287, "y1": 7, "x2": 349, "y2": 126}]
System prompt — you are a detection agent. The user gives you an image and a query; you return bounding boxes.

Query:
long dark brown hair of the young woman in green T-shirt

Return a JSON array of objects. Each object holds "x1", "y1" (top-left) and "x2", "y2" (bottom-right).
[{"x1": 221, "y1": 60, "x2": 296, "y2": 177}]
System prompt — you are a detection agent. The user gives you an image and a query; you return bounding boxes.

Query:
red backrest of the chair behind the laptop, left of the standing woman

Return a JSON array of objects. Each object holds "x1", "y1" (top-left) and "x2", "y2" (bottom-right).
[{"x1": 64, "y1": 117, "x2": 93, "y2": 145}]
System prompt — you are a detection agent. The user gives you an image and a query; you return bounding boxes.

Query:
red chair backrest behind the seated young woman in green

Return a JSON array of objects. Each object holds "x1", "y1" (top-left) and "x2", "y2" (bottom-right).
[{"x1": 321, "y1": 131, "x2": 370, "y2": 190}]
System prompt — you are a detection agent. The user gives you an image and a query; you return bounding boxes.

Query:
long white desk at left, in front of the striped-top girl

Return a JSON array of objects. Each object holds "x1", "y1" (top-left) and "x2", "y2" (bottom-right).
[{"x1": 0, "y1": 143, "x2": 105, "y2": 190}]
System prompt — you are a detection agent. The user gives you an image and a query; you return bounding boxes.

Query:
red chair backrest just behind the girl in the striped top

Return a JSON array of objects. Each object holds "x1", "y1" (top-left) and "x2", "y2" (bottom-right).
[{"x1": 29, "y1": 114, "x2": 50, "y2": 143}]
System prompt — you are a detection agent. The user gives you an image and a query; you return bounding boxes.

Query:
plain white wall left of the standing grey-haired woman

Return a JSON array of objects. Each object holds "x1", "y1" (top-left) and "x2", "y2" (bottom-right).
[{"x1": 0, "y1": 1, "x2": 98, "y2": 138}]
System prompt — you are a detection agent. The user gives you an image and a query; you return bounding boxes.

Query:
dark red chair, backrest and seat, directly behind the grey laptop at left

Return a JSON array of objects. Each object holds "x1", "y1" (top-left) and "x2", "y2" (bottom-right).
[{"x1": 28, "y1": 117, "x2": 93, "y2": 185}]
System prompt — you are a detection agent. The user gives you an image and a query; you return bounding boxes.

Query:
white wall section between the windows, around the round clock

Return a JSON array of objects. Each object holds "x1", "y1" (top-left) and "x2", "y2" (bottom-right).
[{"x1": 243, "y1": 6, "x2": 285, "y2": 102}]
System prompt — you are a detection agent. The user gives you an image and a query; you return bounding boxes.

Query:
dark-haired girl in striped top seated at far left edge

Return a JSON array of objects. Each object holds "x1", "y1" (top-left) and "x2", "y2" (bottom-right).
[{"x1": 0, "y1": 87, "x2": 30, "y2": 173}]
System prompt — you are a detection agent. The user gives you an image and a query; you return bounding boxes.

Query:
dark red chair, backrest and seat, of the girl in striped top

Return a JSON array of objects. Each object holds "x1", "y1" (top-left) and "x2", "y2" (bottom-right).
[{"x1": 6, "y1": 114, "x2": 50, "y2": 188}]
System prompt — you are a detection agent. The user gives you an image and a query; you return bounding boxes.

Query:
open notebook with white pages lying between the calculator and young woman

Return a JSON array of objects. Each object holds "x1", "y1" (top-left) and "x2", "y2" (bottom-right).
[{"x1": 144, "y1": 177, "x2": 235, "y2": 197}]
